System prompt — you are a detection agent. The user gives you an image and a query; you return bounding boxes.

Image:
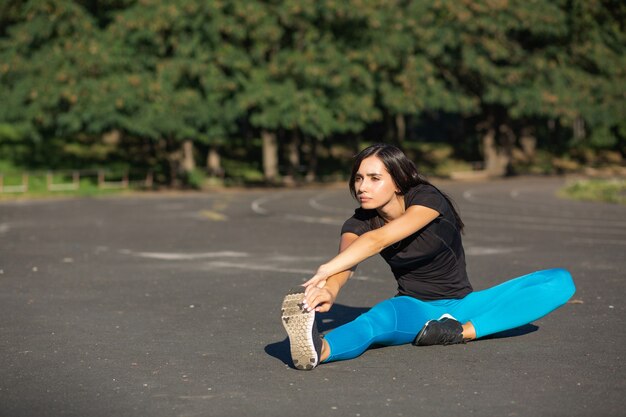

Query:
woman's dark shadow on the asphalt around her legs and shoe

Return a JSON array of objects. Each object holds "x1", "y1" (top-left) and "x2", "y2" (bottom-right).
[{"x1": 265, "y1": 304, "x2": 539, "y2": 366}]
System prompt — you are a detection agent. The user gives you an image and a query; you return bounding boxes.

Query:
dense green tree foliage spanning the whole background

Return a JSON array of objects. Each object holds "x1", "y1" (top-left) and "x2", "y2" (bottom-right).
[{"x1": 0, "y1": 0, "x2": 626, "y2": 182}]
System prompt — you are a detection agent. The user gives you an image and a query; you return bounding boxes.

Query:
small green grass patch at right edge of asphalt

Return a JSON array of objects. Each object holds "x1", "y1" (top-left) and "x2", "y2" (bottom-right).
[{"x1": 559, "y1": 179, "x2": 626, "y2": 204}]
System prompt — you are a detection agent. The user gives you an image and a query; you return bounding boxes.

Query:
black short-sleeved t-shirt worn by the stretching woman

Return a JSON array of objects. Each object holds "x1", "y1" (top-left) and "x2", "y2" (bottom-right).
[{"x1": 341, "y1": 184, "x2": 472, "y2": 301}]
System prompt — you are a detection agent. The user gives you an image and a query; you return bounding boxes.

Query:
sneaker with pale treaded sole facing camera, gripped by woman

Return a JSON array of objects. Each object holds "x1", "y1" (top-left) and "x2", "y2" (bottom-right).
[{"x1": 281, "y1": 287, "x2": 323, "y2": 371}]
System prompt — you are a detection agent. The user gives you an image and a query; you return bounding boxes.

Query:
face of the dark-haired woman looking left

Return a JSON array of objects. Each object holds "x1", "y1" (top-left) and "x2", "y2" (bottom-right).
[{"x1": 354, "y1": 155, "x2": 398, "y2": 209}]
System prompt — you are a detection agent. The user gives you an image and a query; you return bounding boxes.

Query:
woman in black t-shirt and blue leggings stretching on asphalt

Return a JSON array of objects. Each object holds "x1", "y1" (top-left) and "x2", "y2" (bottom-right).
[{"x1": 282, "y1": 144, "x2": 575, "y2": 370}]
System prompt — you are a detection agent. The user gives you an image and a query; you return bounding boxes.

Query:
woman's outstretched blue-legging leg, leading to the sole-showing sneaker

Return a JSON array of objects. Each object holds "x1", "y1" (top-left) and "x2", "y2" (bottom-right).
[{"x1": 324, "y1": 296, "x2": 445, "y2": 362}]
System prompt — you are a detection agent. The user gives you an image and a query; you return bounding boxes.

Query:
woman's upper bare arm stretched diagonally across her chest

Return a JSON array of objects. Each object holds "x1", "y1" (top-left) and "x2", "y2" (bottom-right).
[{"x1": 304, "y1": 206, "x2": 439, "y2": 287}]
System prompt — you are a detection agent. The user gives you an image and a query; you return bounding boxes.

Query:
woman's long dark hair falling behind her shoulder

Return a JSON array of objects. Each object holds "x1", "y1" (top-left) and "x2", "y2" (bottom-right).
[{"x1": 349, "y1": 143, "x2": 465, "y2": 232}]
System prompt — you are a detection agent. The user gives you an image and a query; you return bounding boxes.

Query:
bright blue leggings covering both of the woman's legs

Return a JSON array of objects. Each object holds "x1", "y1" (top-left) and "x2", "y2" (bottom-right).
[{"x1": 325, "y1": 269, "x2": 576, "y2": 362}]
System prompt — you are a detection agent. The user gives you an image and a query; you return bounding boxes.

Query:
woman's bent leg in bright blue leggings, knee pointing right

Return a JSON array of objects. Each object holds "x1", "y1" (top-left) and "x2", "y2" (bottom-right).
[{"x1": 449, "y1": 269, "x2": 576, "y2": 338}]
